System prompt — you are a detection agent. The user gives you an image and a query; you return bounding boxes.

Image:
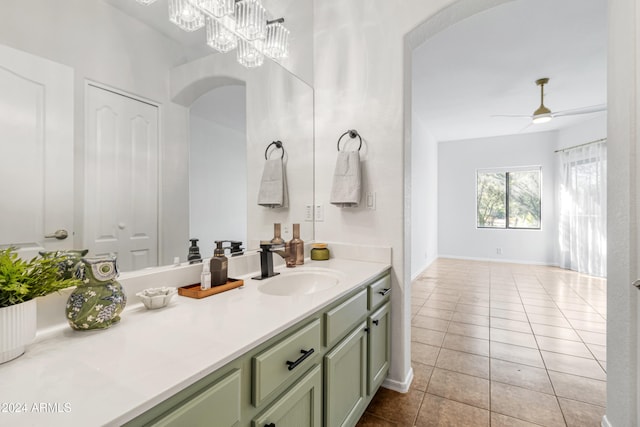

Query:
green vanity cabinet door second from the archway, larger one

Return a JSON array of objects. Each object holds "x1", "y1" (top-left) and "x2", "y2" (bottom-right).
[{"x1": 324, "y1": 322, "x2": 367, "y2": 427}]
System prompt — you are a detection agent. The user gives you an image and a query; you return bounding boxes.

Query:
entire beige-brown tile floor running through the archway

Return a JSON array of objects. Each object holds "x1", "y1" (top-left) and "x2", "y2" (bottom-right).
[{"x1": 358, "y1": 259, "x2": 607, "y2": 427}]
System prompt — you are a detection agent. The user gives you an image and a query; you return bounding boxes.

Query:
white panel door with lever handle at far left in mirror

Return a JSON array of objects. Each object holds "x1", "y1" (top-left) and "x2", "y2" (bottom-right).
[{"x1": 0, "y1": 45, "x2": 74, "y2": 258}]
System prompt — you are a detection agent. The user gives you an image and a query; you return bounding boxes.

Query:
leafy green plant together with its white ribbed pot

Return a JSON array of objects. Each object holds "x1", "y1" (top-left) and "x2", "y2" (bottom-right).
[{"x1": 0, "y1": 248, "x2": 80, "y2": 363}]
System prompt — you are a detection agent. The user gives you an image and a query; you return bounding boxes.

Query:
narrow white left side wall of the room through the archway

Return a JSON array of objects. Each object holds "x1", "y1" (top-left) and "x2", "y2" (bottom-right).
[{"x1": 411, "y1": 112, "x2": 438, "y2": 279}]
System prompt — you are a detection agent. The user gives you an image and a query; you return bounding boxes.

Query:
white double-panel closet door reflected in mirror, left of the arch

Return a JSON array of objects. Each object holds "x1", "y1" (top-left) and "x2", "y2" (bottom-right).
[{"x1": 84, "y1": 85, "x2": 158, "y2": 271}]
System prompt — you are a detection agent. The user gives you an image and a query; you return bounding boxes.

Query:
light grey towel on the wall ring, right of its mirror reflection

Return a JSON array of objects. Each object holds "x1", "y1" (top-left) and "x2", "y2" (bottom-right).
[{"x1": 330, "y1": 151, "x2": 362, "y2": 208}]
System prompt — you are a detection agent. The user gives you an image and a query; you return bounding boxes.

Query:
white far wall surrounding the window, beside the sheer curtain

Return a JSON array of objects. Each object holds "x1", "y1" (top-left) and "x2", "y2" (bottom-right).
[{"x1": 438, "y1": 132, "x2": 557, "y2": 264}]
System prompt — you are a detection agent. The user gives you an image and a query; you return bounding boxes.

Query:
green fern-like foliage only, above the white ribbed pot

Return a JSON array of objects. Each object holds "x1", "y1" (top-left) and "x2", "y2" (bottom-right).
[{"x1": 0, "y1": 248, "x2": 80, "y2": 308}]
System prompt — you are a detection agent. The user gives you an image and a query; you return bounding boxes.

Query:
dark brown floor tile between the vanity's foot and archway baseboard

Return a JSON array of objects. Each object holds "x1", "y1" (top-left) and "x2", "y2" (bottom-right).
[{"x1": 367, "y1": 388, "x2": 424, "y2": 426}]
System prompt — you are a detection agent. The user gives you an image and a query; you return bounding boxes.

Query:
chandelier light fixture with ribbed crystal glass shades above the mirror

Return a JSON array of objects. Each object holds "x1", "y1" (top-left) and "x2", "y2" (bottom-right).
[{"x1": 136, "y1": 0, "x2": 289, "y2": 68}]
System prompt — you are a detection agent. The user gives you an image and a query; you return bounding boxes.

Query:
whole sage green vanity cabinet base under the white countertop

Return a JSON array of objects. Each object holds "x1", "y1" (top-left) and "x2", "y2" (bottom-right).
[{"x1": 120, "y1": 272, "x2": 391, "y2": 427}]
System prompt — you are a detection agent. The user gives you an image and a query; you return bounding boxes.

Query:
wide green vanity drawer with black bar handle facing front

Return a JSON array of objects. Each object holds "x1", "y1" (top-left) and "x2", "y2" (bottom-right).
[{"x1": 251, "y1": 319, "x2": 321, "y2": 407}]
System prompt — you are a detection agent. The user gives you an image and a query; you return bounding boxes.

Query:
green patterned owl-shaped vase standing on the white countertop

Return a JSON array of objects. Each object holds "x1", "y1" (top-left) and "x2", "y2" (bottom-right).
[{"x1": 66, "y1": 256, "x2": 127, "y2": 331}]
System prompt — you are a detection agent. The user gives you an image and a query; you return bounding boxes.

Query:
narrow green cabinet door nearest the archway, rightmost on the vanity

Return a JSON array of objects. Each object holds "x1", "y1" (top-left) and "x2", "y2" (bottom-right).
[{"x1": 367, "y1": 303, "x2": 391, "y2": 395}]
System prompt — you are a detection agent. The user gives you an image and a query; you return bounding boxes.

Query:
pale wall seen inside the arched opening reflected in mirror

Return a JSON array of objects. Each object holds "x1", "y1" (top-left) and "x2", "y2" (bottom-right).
[{"x1": 189, "y1": 85, "x2": 247, "y2": 258}]
